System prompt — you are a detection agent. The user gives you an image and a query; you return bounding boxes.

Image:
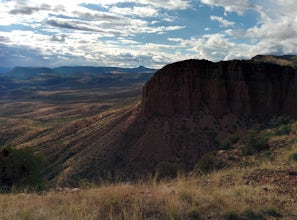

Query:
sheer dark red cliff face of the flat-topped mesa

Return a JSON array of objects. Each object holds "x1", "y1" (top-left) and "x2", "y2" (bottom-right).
[{"x1": 142, "y1": 60, "x2": 297, "y2": 119}]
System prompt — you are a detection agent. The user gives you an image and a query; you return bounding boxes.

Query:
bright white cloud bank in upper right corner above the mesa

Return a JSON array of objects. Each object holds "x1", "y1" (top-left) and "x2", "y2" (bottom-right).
[{"x1": 223, "y1": 0, "x2": 297, "y2": 55}]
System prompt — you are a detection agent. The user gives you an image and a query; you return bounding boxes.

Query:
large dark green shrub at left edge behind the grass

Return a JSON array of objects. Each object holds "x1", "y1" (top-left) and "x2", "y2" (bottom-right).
[{"x1": 0, "y1": 147, "x2": 45, "y2": 190}]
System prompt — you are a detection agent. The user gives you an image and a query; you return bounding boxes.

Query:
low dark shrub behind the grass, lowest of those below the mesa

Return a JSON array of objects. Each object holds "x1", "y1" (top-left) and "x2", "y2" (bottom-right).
[{"x1": 155, "y1": 161, "x2": 185, "y2": 181}]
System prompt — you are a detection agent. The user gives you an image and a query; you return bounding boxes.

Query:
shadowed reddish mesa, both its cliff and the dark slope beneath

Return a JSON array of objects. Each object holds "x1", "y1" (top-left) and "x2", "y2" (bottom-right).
[{"x1": 44, "y1": 55, "x2": 297, "y2": 186}]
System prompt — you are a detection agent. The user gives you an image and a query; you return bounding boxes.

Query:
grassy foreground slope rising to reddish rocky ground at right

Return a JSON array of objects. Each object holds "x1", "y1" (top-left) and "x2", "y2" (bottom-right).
[{"x1": 0, "y1": 117, "x2": 297, "y2": 220}]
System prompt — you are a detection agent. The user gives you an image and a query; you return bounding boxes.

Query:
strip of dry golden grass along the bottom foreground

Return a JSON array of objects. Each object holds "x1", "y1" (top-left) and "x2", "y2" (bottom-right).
[{"x1": 0, "y1": 169, "x2": 297, "y2": 220}]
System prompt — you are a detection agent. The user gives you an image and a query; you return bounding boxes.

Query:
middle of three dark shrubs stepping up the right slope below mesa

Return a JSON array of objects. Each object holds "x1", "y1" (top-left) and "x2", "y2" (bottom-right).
[{"x1": 195, "y1": 152, "x2": 224, "y2": 174}]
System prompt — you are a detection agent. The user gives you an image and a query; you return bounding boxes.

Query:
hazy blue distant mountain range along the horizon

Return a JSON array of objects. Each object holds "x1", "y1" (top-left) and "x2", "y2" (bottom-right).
[{"x1": 1, "y1": 66, "x2": 155, "y2": 90}]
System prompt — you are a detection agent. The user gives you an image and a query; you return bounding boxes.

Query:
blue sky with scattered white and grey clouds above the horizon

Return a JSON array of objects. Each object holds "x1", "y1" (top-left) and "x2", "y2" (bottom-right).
[{"x1": 0, "y1": 0, "x2": 297, "y2": 68}]
